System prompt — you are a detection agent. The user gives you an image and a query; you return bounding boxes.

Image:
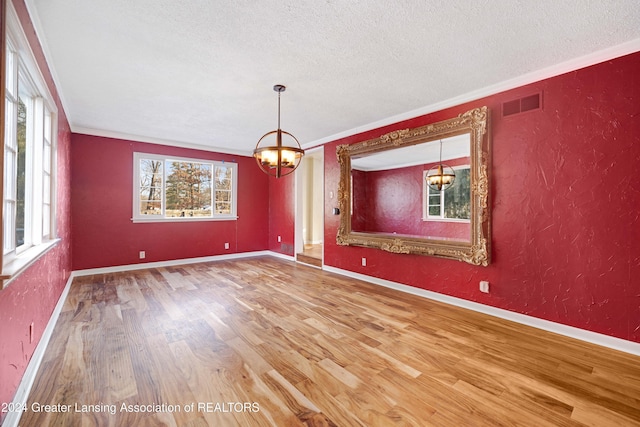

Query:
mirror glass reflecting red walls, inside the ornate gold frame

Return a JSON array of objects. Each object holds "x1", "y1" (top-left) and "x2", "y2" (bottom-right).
[{"x1": 351, "y1": 133, "x2": 471, "y2": 242}]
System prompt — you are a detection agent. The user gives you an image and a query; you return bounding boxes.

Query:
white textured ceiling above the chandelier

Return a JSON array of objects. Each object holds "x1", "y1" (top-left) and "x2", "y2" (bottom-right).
[{"x1": 26, "y1": 0, "x2": 640, "y2": 154}]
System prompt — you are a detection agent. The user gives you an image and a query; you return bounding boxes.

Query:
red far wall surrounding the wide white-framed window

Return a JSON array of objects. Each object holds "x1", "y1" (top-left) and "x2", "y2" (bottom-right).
[{"x1": 72, "y1": 134, "x2": 269, "y2": 270}]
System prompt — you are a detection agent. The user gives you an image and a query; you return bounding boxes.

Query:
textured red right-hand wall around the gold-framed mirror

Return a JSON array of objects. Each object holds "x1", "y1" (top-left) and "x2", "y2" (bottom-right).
[{"x1": 324, "y1": 53, "x2": 640, "y2": 342}]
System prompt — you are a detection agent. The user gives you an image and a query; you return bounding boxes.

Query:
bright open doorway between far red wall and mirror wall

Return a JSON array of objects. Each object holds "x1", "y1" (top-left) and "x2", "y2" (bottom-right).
[{"x1": 296, "y1": 147, "x2": 324, "y2": 268}]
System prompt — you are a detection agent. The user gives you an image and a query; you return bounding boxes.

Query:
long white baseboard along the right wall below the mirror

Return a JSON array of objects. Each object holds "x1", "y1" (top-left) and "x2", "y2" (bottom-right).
[{"x1": 323, "y1": 265, "x2": 640, "y2": 356}]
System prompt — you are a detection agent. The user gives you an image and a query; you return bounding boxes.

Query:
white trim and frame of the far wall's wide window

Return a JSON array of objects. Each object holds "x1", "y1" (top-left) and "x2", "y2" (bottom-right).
[{"x1": 131, "y1": 152, "x2": 238, "y2": 223}]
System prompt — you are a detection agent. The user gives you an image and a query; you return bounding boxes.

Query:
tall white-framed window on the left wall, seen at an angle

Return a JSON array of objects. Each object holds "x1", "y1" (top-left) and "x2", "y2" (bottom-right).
[{"x1": 0, "y1": 3, "x2": 57, "y2": 288}]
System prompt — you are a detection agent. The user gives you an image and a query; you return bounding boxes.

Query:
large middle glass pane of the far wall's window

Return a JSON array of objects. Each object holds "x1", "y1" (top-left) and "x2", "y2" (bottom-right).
[{"x1": 165, "y1": 160, "x2": 211, "y2": 218}]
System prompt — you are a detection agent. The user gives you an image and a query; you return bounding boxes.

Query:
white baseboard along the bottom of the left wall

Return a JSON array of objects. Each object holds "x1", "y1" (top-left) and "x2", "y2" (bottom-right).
[{"x1": 2, "y1": 274, "x2": 73, "y2": 427}]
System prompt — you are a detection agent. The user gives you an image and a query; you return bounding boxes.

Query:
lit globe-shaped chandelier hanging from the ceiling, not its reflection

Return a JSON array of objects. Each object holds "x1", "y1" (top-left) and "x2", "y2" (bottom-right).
[{"x1": 253, "y1": 85, "x2": 304, "y2": 178}]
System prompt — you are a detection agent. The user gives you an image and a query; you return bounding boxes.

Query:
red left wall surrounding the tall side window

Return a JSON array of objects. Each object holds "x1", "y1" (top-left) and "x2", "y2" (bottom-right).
[{"x1": 0, "y1": 0, "x2": 71, "y2": 422}]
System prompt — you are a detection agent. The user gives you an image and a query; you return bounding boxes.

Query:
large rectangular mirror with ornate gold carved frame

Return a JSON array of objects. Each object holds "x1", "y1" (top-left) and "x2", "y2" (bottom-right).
[{"x1": 336, "y1": 107, "x2": 491, "y2": 266}]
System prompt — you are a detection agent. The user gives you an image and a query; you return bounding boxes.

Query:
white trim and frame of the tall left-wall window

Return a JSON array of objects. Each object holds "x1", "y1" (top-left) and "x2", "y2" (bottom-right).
[{"x1": 0, "y1": 2, "x2": 61, "y2": 289}]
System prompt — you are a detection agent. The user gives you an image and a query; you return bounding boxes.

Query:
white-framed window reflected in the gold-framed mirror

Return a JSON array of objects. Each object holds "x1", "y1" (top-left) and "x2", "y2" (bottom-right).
[{"x1": 422, "y1": 166, "x2": 471, "y2": 221}]
